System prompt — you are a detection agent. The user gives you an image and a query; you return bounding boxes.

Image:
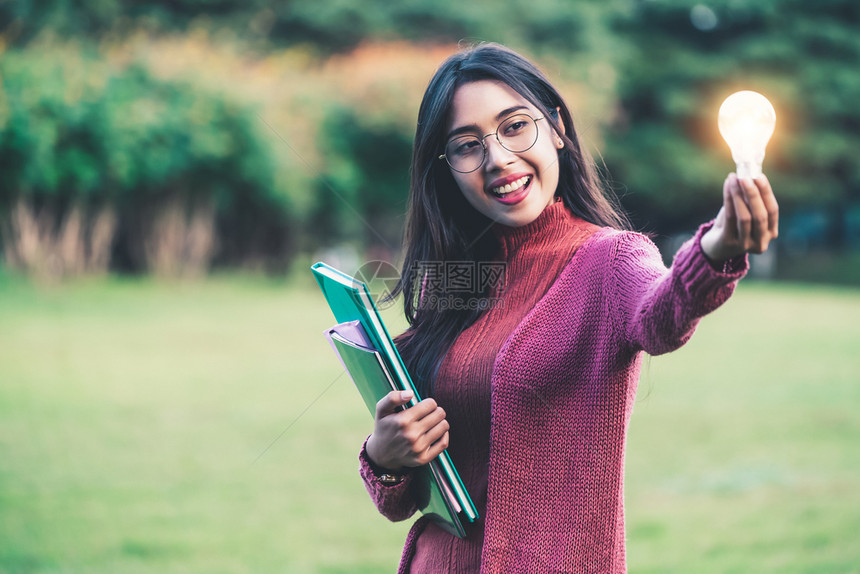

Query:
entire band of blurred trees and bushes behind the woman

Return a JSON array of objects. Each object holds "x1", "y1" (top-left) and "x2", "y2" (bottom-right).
[{"x1": 0, "y1": 0, "x2": 860, "y2": 276}]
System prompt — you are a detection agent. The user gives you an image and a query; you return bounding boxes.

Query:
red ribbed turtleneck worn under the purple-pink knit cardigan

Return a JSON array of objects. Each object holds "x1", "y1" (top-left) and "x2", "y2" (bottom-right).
[{"x1": 412, "y1": 202, "x2": 599, "y2": 573}]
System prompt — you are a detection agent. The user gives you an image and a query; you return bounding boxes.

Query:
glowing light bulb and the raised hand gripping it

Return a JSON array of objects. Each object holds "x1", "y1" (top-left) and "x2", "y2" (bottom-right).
[{"x1": 701, "y1": 91, "x2": 779, "y2": 262}]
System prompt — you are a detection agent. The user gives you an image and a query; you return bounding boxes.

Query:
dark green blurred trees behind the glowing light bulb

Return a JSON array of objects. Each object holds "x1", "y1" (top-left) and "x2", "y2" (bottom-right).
[{"x1": 606, "y1": 0, "x2": 860, "y2": 238}]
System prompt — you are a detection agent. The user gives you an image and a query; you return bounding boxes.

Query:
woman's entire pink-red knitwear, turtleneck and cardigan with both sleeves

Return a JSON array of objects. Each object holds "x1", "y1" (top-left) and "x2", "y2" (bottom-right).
[{"x1": 360, "y1": 203, "x2": 746, "y2": 573}]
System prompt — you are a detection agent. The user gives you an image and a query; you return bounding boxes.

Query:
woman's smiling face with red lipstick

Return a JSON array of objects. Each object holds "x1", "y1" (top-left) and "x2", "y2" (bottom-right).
[{"x1": 446, "y1": 80, "x2": 559, "y2": 227}]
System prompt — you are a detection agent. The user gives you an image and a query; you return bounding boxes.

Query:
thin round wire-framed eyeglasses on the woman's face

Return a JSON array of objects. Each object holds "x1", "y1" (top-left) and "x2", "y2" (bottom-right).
[{"x1": 439, "y1": 114, "x2": 543, "y2": 173}]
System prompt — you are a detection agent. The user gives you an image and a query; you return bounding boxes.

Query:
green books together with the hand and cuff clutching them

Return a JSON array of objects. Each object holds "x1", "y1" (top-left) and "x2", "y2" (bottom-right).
[{"x1": 312, "y1": 262, "x2": 478, "y2": 537}]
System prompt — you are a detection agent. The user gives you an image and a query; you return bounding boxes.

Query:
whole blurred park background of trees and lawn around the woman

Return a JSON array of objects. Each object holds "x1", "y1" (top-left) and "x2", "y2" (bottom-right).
[{"x1": 0, "y1": 0, "x2": 860, "y2": 572}]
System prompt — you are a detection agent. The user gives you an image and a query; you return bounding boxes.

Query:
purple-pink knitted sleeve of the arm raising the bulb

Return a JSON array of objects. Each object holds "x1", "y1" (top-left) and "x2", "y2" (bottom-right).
[{"x1": 609, "y1": 222, "x2": 749, "y2": 355}]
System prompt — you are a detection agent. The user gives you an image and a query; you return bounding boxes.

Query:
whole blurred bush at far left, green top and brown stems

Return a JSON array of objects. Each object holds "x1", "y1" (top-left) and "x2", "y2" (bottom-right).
[{"x1": 0, "y1": 43, "x2": 288, "y2": 275}]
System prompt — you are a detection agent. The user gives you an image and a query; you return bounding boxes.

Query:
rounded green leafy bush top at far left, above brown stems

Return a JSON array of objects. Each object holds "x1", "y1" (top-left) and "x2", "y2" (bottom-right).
[{"x1": 0, "y1": 46, "x2": 270, "y2": 206}]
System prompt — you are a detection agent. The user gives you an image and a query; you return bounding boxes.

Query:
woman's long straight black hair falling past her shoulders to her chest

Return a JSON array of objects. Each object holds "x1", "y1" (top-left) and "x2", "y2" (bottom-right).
[{"x1": 391, "y1": 43, "x2": 629, "y2": 396}]
